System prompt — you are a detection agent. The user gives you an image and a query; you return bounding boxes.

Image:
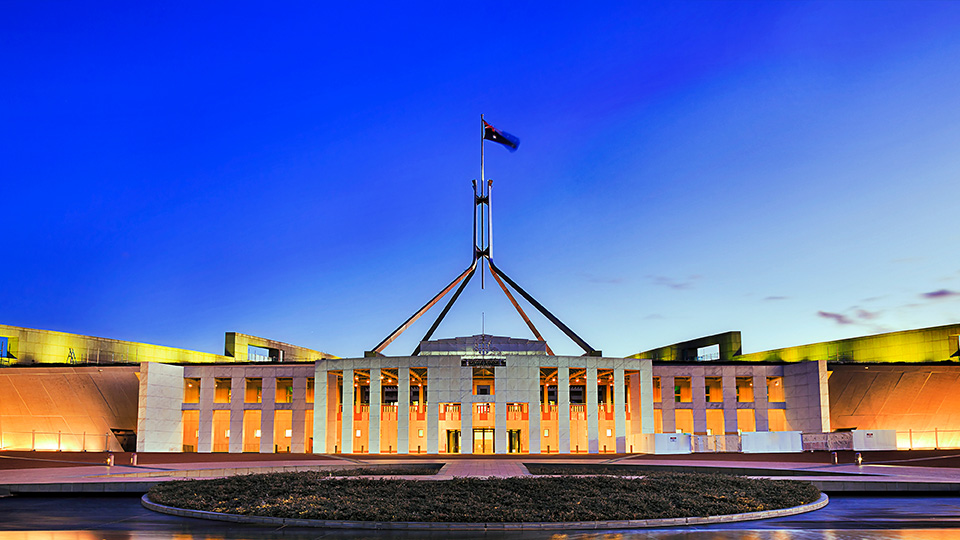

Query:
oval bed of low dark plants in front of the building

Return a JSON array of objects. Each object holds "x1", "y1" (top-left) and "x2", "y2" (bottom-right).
[{"x1": 149, "y1": 472, "x2": 820, "y2": 522}]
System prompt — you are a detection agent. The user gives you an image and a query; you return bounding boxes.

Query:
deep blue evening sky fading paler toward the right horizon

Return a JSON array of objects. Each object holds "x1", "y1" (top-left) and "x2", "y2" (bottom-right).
[{"x1": 0, "y1": 1, "x2": 960, "y2": 356}]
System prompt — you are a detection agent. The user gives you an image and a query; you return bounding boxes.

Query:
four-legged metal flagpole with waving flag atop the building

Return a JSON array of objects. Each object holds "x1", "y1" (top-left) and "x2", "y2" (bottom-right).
[{"x1": 364, "y1": 114, "x2": 603, "y2": 356}]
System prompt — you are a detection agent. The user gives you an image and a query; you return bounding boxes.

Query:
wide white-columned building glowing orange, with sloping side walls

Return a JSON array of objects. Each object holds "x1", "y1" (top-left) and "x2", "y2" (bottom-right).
[{"x1": 0, "y1": 324, "x2": 960, "y2": 454}]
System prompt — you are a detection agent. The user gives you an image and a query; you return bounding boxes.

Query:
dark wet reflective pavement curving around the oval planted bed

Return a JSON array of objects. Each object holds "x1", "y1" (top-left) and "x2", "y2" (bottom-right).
[{"x1": 0, "y1": 496, "x2": 960, "y2": 540}]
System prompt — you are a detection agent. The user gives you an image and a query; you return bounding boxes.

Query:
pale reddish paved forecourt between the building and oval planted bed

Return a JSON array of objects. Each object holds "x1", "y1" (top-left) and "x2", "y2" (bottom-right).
[{"x1": 0, "y1": 452, "x2": 960, "y2": 494}]
